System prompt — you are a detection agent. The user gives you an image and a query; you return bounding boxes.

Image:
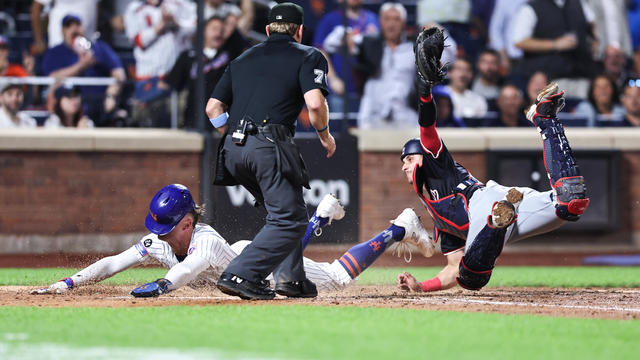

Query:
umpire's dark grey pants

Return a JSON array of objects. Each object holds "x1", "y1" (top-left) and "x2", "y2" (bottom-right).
[{"x1": 222, "y1": 133, "x2": 308, "y2": 283}]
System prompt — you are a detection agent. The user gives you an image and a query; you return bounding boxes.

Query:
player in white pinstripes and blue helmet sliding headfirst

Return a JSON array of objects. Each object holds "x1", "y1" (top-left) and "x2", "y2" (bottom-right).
[{"x1": 31, "y1": 184, "x2": 434, "y2": 297}]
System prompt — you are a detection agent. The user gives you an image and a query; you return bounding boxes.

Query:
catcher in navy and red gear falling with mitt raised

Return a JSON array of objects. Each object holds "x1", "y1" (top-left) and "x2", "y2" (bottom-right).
[{"x1": 398, "y1": 28, "x2": 589, "y2": 291}]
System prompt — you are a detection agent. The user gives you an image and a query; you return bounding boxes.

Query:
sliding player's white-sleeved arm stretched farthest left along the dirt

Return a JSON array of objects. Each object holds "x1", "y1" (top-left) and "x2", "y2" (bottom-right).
[{"x1": 31, "y1": 244, "x2": 148, "y2": 294}]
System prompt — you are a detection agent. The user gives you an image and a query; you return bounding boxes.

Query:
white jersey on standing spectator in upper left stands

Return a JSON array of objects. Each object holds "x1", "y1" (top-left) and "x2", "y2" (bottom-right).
[{"x1": 124, "y1": 0, "x2": 197, "y2": 78}]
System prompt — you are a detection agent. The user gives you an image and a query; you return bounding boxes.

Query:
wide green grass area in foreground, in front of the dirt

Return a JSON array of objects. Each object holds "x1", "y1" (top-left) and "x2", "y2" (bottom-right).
[{"x1": 0, "y1": 305, "x2": 640, "y2": 360}]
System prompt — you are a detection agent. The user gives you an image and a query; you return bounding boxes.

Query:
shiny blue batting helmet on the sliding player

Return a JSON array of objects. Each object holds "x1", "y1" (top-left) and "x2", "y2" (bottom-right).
[{"x1": 144, "y1": 184, "x2": 196, "y2": 235}]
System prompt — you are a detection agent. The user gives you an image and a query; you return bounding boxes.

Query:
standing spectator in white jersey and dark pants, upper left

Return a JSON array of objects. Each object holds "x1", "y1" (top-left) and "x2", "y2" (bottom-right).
[{"x1": 124, "y1": 0, "x2": 197, "y2": 127}]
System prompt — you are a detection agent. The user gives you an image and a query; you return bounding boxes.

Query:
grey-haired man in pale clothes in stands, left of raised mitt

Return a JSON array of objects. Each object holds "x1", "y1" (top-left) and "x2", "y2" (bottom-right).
[{"x1": 358, "y1": 2, "x2": 418, "y2": 129}]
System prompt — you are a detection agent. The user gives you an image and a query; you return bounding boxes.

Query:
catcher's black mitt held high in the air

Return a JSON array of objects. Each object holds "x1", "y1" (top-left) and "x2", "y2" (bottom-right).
[{"x1": 413, "y1": 27, "x2": 444, "y2": 84}]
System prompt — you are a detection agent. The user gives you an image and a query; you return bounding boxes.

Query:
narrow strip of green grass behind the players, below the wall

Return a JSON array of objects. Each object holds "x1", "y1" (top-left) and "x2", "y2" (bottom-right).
[{"x1": 0, "y1": 266, "x2": 640, "y2": 287}]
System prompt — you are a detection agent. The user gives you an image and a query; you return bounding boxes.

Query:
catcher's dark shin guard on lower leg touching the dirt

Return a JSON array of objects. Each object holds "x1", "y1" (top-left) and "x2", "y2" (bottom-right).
[{"x1": 456, "y1": 222, "x2": 507, "y2": 290}]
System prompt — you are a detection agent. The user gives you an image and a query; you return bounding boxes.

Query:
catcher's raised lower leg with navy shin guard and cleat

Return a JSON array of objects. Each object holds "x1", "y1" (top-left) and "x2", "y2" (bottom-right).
[{"x1": 527, "y1": 83, "x2": 589, "y2": 221}]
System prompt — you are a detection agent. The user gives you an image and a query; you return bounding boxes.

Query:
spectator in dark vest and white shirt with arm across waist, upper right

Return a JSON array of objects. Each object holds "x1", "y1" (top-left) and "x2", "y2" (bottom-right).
[{"x1": 512, "y1": 0, "x2": 596, "y2": 79}]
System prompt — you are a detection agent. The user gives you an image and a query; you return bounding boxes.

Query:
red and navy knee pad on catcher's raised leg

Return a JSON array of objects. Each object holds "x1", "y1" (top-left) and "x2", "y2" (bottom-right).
[{"x1": 553, "y1": 176, "x2": 589, "y2": 221}]
